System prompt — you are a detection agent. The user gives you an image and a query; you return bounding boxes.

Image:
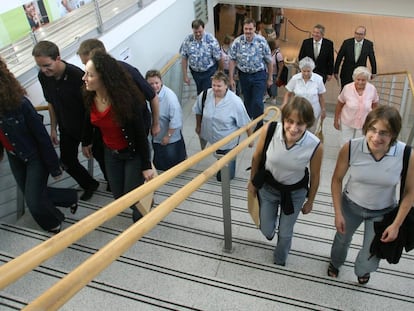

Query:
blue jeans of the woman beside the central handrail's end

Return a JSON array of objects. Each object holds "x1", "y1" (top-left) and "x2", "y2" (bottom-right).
[{"x1": 258, "y1": 183, "x2": 307, "y2": 265}]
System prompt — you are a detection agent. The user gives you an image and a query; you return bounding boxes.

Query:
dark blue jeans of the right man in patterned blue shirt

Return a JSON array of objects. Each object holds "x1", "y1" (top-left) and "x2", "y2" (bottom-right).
[{"x1": 239, "y1": 70, "x2": 267, "y2": 128}]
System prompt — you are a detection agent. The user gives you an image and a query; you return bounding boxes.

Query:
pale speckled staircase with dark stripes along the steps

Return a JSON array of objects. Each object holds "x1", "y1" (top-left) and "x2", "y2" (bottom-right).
[{"x1": 0, "y1": 84, "x2": 414, "y2": 310}]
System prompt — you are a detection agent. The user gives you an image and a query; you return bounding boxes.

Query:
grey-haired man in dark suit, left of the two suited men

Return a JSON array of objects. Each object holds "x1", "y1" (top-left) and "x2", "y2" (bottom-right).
[{"x1": 299, "y1": 24, "x2": 334, "y2": 83}]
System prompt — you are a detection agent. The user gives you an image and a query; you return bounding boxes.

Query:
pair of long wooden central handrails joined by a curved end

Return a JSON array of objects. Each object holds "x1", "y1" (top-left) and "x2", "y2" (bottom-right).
[{"x1": 0, "y1": 106, "x2": 280, "y2": 310}]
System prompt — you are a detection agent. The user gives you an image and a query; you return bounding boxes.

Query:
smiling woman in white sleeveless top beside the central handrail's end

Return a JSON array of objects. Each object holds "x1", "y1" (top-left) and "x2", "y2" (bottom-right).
[{"x1": 248, "y1": 96, "x2": 323, "y2": 266}]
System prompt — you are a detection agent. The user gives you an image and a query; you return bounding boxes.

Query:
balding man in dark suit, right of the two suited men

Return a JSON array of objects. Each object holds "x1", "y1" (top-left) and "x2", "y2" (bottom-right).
[{"x1": 334, "y1": 26, "x2": 377, "y2": 88}]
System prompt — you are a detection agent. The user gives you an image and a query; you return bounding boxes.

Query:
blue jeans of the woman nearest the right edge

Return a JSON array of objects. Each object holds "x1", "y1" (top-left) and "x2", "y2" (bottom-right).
[{"x1": 331, "y1": 194, "x2": 393, "y2": 276}]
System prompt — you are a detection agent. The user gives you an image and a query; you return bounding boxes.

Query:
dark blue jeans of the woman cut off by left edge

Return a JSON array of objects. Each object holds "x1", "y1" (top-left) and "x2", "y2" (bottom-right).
[{"x1": 7, "y1": 153, "x2": 64, "y2": 231}]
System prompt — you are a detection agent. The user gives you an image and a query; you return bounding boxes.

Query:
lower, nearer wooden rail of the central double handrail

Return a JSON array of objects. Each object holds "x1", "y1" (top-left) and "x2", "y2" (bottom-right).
[{"x1": 23, "y1": 107, "x2": 280, "y2": 310}]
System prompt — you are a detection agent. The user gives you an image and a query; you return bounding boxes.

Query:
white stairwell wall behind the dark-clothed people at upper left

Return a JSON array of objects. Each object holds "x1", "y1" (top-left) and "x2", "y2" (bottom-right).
[{"x1": 25, "y1": 0, "x2": 196, "y2": 104}]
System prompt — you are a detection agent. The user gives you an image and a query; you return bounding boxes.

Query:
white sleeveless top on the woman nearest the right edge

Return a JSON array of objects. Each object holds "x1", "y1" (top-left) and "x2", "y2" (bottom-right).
[{"x1": 344, "y1": 137, "x2": 405, "y2": 210}]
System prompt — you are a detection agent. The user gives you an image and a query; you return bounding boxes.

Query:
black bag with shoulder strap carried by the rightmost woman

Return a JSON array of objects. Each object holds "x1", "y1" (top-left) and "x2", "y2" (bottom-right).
[{"x1": 370, "y1": 145, "x2": 414, "y2": 264}]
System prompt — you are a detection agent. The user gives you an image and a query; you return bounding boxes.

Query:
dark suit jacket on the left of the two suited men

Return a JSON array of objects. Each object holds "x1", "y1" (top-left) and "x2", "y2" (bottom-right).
[{"x1": 299, "y1": 38, "x2": 334, "y2": 83}]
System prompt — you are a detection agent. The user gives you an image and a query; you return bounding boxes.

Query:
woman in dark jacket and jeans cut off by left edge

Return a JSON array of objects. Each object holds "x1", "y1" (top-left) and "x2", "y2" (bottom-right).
[{"x1": 0, "y1": 60, "x2": 78, "y2": 233}]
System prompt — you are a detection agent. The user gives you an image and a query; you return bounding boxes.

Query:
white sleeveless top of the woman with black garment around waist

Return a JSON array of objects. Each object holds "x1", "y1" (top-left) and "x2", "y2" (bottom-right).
[{"x1": 265, "y1": 122, "x2": 320, "y2": 185}]
